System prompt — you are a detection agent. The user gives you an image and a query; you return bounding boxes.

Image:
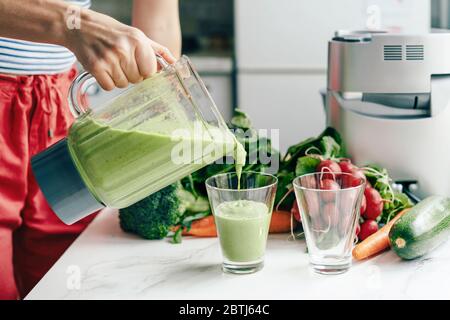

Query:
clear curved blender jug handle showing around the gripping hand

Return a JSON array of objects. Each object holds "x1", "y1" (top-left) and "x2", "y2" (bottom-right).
[{"x1": 69, "y1": 53, "x2": 170, "y2": 118}]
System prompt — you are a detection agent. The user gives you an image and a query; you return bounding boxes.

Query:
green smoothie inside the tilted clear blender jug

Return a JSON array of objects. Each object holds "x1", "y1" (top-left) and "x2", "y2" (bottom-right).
[{"x1": 69, "y1": 117, "x2": 245, "y2": 208}]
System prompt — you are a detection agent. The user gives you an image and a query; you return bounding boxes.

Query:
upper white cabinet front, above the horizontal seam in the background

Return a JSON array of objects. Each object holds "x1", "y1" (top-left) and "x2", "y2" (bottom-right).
[{"x1": 234, "y1": 0, "x2": 431, "y2": 71}]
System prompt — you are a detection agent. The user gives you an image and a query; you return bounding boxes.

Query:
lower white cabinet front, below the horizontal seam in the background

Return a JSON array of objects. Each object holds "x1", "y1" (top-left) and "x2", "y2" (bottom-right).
[{"x1": 238, "y1": 74, "x2": 326, "y2": 152}]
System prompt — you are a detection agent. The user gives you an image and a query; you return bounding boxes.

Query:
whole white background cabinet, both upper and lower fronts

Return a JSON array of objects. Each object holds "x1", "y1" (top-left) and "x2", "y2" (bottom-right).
[{"x1": 234, "y1": 0, "x2": 431, "y2": 151}]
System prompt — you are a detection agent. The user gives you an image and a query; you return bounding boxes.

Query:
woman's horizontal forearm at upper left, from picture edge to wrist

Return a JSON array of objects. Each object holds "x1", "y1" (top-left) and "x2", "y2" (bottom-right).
[{"x1": 0, "y1": 0, "x2": 70, "y2": 45}]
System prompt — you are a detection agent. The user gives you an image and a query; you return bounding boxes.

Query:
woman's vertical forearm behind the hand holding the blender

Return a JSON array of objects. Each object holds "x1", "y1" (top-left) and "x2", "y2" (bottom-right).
[{"x1": 133, "y1": 0, "x2": 181, "y2": 57}]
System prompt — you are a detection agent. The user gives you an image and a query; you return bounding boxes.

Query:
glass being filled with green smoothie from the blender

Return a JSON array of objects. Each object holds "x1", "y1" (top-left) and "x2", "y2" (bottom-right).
[{"x1": 206, "y1": 172, "x2": 277, "y2": 274}]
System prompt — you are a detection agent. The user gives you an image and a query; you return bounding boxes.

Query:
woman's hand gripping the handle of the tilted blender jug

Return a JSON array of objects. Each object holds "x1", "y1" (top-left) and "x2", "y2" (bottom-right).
[{"x1": 70, "y1": 11, "x2": 176, "y2": 90}]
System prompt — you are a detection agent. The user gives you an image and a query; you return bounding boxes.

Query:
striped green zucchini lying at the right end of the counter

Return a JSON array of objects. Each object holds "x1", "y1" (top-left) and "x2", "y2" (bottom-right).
[{"x1": 389, "y1": 196, "x2": 450, "y2": 260}]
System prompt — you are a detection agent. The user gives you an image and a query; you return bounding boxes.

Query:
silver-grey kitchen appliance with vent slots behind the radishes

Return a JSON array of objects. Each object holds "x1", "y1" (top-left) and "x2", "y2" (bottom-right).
[{"x1": 325, "y1": 31, "x2": 450, "y2": 197}]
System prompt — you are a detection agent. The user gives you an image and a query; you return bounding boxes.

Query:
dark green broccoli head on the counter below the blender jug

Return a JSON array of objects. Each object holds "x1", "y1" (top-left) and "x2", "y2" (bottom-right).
[{"x1": 119, "y1": 184, "x2": 185, "y2": 239}]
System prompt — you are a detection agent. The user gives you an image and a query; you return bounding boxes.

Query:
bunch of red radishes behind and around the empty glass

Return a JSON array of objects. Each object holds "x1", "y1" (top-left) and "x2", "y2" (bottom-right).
[{"x1": 291, "y1": 159, "x2": 384, "y2": 240}]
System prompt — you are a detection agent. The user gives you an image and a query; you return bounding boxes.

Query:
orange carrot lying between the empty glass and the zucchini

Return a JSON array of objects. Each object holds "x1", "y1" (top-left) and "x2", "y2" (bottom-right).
[{"x1": 352, "y1": 208, "x2": 411, "y2": 260}]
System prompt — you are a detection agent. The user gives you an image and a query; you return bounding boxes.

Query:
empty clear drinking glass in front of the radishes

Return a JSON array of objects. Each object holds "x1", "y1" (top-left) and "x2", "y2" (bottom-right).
[{"x1": 294, "y1": 172, "x2": 366, "y2": 274}]
